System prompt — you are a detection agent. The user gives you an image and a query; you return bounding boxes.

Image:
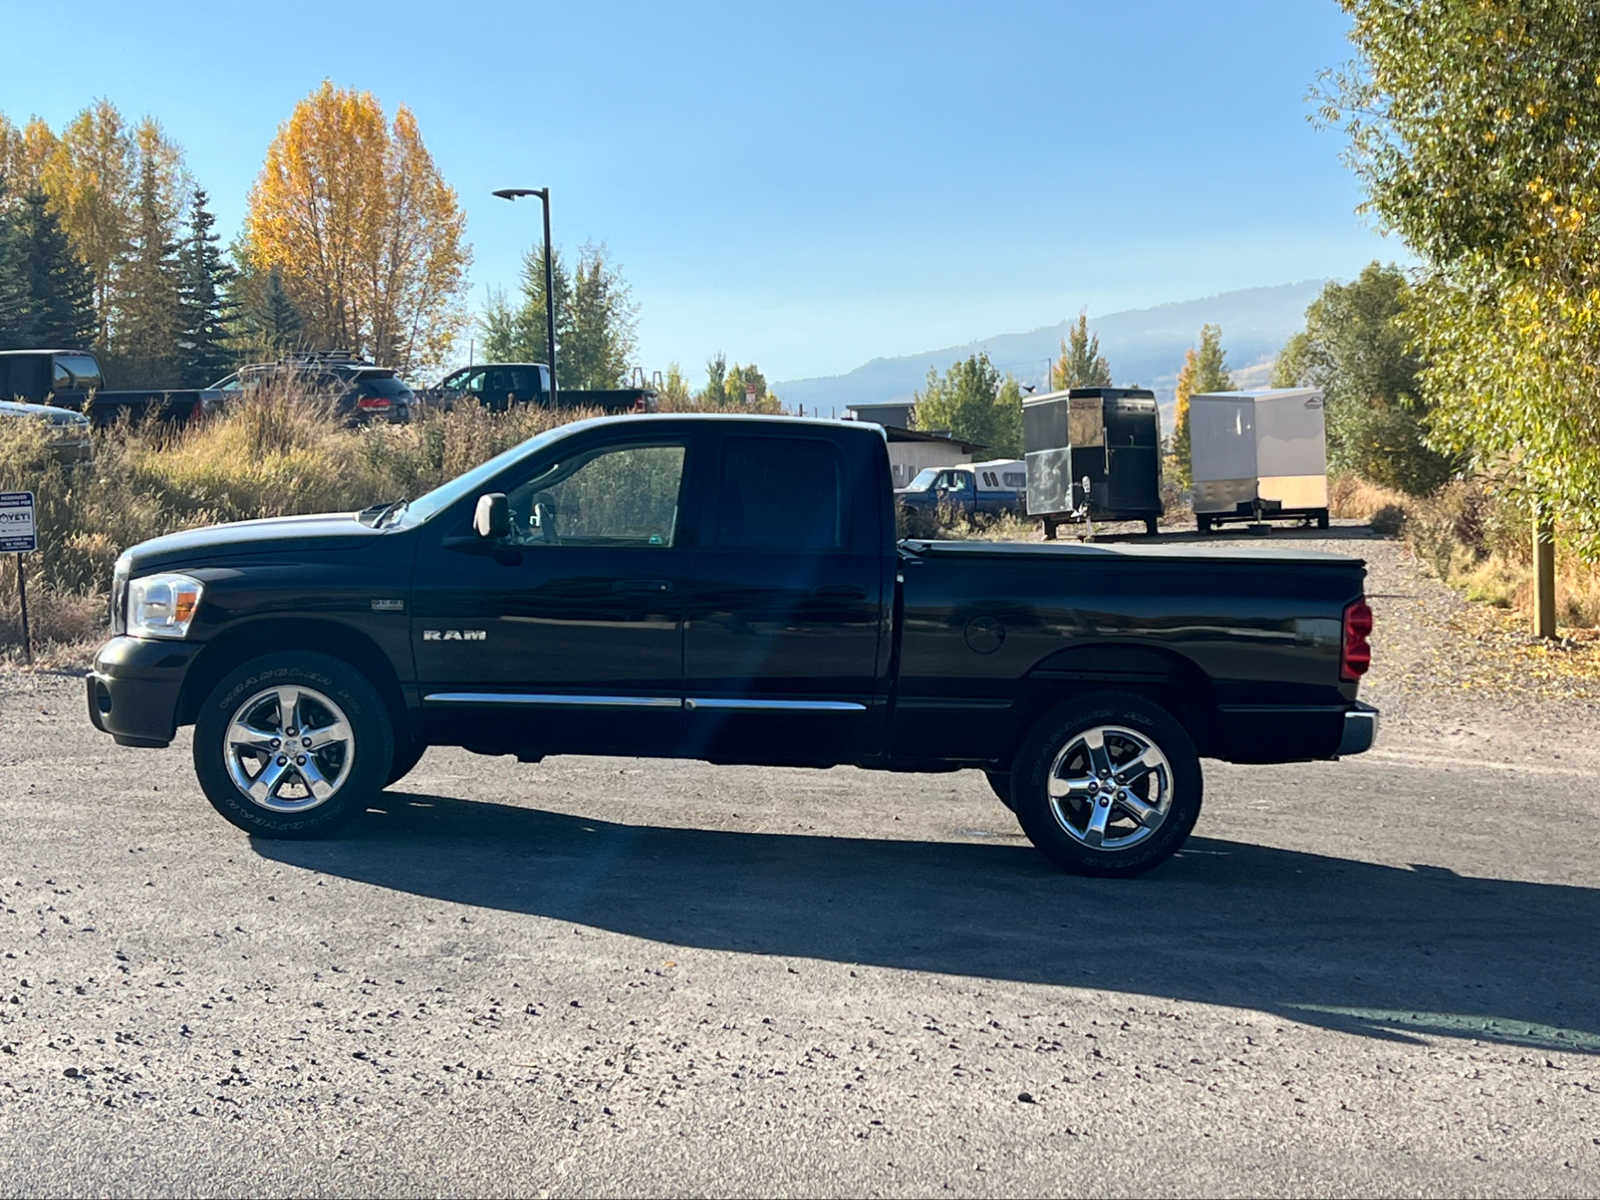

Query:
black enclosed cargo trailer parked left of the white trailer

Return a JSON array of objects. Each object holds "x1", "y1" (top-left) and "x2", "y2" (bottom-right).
[{"x1": 1022, "y1": 387, "x2": 1162, "y2": 538}]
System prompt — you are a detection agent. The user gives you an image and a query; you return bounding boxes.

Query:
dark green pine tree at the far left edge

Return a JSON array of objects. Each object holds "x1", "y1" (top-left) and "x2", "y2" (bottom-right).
[{"x1": 8, "y1": 189, "x2": 96, "y2": 349}]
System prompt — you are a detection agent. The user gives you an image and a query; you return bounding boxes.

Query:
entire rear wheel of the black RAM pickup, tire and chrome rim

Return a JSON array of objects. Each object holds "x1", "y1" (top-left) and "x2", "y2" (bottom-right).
[{"x1": 1011, "y1": 691, "x2": 1203, "y2": 875}]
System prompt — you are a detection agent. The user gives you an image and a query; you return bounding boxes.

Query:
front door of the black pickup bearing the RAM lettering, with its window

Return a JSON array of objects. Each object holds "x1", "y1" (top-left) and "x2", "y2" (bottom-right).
[{"x1": 411, "y1": 432, "x2": 691, "y2": 754}]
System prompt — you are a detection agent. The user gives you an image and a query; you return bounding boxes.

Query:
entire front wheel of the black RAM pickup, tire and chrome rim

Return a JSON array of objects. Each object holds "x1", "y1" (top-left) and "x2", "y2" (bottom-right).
[{"x1": 194, "y1": 651, "x2": 395, "y2": 837}]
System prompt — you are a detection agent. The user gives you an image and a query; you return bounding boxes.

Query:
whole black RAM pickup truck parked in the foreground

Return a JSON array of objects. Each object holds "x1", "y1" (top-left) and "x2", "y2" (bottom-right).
[{"x1": 88, "y1": 414, "x2": 1378, "y2": 875}]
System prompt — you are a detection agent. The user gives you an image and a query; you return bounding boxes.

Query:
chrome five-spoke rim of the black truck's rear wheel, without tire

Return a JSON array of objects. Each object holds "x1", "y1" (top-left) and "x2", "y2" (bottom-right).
[{"x1": 1045, "y1": 725, "x2": 1174, "y2": 850}]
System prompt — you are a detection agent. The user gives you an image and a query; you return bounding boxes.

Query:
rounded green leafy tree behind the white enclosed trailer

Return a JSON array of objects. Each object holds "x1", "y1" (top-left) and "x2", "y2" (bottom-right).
[{"x1": 1272, "y1": 262, "x2": 1456, "y2": 496}]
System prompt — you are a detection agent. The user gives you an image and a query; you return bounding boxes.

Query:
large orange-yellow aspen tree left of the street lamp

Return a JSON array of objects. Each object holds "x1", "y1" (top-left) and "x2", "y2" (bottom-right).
[{"x1": 245, "y1": 82, "x2": 470, "y2": 371}]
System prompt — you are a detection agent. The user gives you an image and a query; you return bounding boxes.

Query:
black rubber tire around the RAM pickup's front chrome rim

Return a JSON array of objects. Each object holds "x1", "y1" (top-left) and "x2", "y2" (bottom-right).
[{"x1": 194, "y1": 651, "x2": 395, "y2": 838}]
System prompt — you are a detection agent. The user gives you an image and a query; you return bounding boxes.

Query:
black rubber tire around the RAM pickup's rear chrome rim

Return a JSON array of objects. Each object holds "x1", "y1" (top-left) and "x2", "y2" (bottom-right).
[{"x1": 1011, "y1": 691, "x2": 1203, "y2": 875}]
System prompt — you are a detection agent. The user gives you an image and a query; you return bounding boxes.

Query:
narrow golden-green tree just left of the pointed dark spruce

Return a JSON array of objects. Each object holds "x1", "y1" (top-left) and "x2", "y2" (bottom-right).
[{"x1": 114, "y1": 157, "x2": 182, "y2": 387}]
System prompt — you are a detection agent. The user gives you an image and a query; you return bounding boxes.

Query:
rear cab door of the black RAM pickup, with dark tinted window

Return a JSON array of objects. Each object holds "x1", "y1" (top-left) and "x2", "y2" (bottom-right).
[{"x1": 683, "y1": 429, "x2": 888, "y2": 762}]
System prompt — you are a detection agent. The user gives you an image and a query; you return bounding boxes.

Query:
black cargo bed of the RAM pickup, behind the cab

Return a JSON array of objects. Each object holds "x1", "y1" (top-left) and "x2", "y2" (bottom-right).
[{"x1": 894, "y1": 541, "x2": 1366, "y2": 762}]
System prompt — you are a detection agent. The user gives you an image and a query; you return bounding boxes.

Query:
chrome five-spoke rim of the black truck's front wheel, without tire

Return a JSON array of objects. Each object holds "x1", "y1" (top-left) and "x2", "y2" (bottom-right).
[{"x1": 222, "y1": 683, "x2": 355, "y2": 813}]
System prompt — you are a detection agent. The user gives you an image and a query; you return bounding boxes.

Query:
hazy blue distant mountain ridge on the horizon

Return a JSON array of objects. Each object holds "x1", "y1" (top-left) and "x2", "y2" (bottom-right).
[{"x1": 773, "y1": 278, "x2": 1326, "y2": 428}]
